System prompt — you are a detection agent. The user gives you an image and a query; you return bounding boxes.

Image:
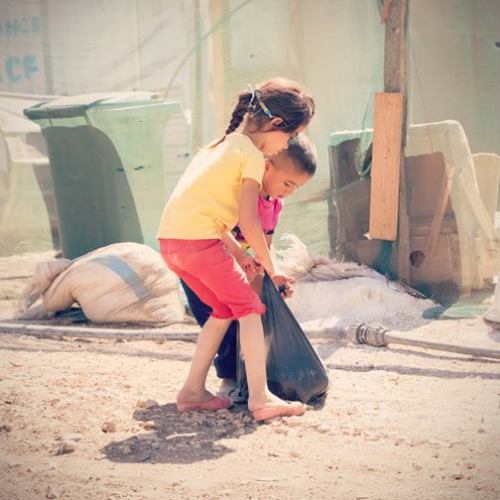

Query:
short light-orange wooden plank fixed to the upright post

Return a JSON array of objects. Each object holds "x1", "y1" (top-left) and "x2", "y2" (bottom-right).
[{"x1": 369, "y1": 92, "x2": 403, "y2": 241}]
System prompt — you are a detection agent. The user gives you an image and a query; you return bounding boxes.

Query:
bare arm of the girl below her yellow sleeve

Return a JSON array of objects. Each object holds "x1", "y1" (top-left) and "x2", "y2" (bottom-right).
[{"x1": 239, "y1": 179, "x2": 275, "y2": 277}]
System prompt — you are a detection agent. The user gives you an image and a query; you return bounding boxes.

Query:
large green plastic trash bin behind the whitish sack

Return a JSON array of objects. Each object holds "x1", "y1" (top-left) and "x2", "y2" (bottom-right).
[{"x1": 24, "y1": 92, "x2": 181, "y2": 259}]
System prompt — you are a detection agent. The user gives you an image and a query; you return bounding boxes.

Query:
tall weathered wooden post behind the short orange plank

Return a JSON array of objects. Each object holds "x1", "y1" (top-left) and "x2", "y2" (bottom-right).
[{"x1": 384, "y1": 0, "x2": 410, "y2": 283}]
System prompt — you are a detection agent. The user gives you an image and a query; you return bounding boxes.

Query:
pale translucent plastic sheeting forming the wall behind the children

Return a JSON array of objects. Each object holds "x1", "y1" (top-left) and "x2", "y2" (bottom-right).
[{"x1": 0, "y1": 0, "x2": 500, "y2": 306}]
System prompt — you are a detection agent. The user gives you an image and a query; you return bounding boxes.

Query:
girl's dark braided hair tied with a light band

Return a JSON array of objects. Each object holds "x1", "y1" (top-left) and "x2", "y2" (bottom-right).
[{"x1": 213, "y1": 78, "x2": 315, "y2": 146}]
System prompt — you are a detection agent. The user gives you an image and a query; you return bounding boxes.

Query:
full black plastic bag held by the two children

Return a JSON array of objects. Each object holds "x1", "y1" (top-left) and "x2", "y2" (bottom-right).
[{"x1": 235, "y1": 274, "x2": 328, "y2": 403}]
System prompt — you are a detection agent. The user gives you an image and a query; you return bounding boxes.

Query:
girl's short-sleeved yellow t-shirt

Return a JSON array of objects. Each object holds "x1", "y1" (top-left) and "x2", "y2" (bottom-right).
[{"x1": 156, "y1": 132, "x2": 265, "y2": 240}]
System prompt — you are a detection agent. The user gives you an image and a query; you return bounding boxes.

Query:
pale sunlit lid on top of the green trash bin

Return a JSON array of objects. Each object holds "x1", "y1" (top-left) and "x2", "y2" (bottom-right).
[{"x1": 24, "y1": 91, "x2": 171, "y2": 120}]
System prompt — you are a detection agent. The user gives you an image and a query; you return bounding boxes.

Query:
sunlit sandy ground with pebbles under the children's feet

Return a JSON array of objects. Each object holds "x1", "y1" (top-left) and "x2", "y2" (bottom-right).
[{"x1": 0, "y1": 256, "x2": 500, "y2": 500}]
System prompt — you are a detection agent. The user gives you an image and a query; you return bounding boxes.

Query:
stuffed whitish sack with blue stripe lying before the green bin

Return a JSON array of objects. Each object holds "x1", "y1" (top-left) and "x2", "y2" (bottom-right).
[{"x1": 18, "y1": 243, "x2": 184, "y2": 323}]
